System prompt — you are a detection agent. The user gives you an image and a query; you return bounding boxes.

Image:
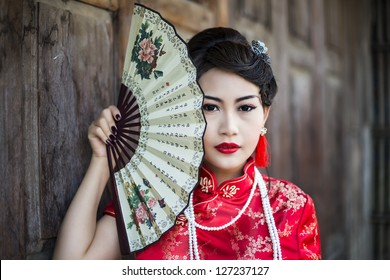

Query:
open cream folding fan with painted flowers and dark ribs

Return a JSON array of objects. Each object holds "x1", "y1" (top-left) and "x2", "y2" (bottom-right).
[{"x1": 107, "y1": 4, "x2": 206, "y2": 255}]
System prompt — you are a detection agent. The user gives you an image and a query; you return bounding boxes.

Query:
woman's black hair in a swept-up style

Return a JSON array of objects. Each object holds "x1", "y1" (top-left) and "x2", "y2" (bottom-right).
[{"x1": 188, "y1": 27, "x2": 277, "y2": 106}]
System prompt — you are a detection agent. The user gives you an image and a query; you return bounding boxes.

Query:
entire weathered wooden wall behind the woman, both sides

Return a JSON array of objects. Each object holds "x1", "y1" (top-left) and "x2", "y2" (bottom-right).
[{"x1": 0, "y1": 0, "x2": 371, "y2": 259}]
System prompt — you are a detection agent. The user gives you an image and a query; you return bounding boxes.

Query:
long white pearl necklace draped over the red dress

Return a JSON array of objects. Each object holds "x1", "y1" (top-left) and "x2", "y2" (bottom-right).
[{"x1": 184, "y1": 168, "x2": 282, "y2": 260}]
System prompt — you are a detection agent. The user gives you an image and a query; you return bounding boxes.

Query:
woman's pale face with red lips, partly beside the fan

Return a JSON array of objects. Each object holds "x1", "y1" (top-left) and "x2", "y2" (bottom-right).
[{"x1": 199, "y1": 68, "x2": 269, "y2": 184}]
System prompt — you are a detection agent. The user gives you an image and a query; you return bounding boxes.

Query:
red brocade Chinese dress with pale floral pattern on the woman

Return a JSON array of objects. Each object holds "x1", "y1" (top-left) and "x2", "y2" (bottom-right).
[{"x1": 105, "y1": 160, "x2": 321, "y2": 260}]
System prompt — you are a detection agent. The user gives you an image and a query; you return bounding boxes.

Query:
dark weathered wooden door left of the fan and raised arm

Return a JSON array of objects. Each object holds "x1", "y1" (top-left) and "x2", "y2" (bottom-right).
[{"x1": 0, "y1": 0, "x2": 132, "y2": 259}]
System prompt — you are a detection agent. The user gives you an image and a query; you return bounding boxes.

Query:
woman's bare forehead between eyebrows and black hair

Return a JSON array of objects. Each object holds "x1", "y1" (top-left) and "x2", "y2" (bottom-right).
[{"x1": 199, "y1": 68, "x2": 260, "y2": 99}]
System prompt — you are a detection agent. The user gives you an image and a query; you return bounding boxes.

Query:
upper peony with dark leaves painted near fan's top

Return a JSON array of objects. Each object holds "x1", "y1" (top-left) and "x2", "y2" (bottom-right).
[{"x1": 131, "y1": 21, "x2": 166, "y2": 79}]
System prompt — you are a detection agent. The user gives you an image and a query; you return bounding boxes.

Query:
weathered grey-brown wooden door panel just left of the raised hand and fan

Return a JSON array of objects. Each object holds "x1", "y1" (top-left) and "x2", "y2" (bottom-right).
[{"x1": 37, "y1": 2, "x2": 117, "y2": 239}]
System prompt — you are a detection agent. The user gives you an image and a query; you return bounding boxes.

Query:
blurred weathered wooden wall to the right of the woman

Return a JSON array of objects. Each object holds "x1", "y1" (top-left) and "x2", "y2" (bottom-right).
[{"x1": 229, "y1": 0, "x2": 372, "y2": 259}]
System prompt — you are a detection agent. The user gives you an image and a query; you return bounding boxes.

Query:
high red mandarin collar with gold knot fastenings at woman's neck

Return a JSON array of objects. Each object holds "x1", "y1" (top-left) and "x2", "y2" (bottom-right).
[{"x1": 196, "y1": 158, "x2": 255, "y2": 199}]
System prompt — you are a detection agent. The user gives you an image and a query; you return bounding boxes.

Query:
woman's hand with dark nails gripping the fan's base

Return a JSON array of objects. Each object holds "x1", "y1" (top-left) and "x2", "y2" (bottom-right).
[{"x1": 88, "y1": 105, "x2": 121, "y2": 157}]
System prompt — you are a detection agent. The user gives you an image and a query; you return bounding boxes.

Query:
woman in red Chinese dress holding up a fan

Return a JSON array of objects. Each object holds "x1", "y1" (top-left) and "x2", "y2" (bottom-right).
[{"x1": 54, "y1": 28, "x2": 321, "y2": 259}]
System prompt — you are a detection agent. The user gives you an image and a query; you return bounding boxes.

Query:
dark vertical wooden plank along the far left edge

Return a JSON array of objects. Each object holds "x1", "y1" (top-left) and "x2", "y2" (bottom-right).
[{"x1": 0, "y1": 0, "x2": 25, "y2": 259}]
